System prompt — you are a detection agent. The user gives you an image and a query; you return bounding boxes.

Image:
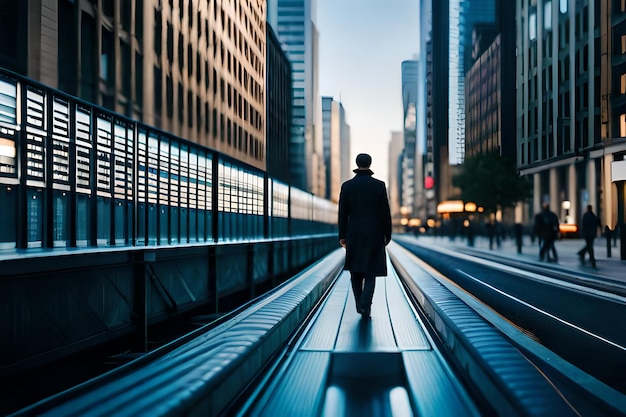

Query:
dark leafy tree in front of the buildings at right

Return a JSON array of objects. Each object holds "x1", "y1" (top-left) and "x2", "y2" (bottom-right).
[{"x1": 453, "y1": 152, "x2": 532, "y2": 212}]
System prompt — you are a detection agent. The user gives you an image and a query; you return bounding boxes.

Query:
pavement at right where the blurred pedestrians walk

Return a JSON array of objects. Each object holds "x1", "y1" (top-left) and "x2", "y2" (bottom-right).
[{"x1": 404, "y1": 235, "x2": 626, "y2": 284}]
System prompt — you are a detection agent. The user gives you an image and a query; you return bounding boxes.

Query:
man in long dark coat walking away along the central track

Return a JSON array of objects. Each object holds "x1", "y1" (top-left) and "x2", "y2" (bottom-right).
[{"x1": 339, "y1": 153, "x2": 391, "y2": 318}]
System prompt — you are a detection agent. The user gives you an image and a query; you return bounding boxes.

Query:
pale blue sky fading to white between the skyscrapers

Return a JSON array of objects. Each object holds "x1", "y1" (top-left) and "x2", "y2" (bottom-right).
[{"x1": 315, "y1": 0, "x2": 419, "y2": 181}]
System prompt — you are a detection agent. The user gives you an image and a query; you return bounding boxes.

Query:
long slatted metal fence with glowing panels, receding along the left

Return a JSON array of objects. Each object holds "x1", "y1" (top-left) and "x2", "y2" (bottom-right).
[{"x1": 0, "y1": 70, "x2": 336, "y2": 248}]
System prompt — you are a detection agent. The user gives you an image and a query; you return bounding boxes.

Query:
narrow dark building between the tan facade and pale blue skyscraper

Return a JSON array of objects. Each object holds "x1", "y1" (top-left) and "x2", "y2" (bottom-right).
[{"x1": 265, "y1": 25, "x2": 292, "y2": 184}]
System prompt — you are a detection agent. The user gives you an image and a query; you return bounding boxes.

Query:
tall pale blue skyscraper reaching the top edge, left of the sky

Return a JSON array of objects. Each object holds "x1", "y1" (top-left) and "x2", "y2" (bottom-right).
[{"x1": 267, "y1": 0, "x2": 325, "y2": 194}]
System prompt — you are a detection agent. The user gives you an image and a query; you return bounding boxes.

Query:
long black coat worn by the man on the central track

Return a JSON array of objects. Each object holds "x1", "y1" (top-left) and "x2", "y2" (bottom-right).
[{"x1": 339, "y1": 169, "x2": 391, "y2": 276}]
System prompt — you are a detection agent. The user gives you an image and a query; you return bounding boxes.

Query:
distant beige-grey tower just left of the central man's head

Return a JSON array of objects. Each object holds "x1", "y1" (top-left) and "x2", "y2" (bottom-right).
[{"x1": 322, "y1": 97, "x2": 351, "y2": 202}]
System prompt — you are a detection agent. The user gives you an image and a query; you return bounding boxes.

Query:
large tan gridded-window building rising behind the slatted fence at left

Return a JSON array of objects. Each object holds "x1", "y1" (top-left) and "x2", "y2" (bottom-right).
[{"x1": 0, "y1": 0, "x2": 266, "y2": 169}]
